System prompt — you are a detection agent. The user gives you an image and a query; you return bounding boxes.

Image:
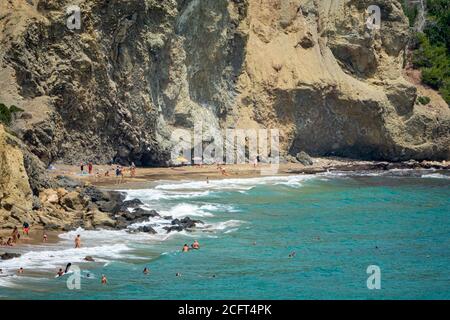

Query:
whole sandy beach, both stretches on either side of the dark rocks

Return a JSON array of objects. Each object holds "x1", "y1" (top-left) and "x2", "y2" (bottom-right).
[{"x1": 0, "y1": 158, "x2": 450, "y2": 253}]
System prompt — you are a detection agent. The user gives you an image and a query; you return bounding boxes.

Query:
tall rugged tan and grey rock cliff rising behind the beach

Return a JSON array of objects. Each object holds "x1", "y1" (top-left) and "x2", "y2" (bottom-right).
[{"x1": 0, "y1": 0, "x2": 450, "y2": 165}]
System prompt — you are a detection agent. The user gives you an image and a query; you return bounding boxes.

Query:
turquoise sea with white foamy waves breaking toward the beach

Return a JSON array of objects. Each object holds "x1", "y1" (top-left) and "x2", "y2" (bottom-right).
[{"x1": 0, "y1": 171, "x2": 450, "y2": 299}]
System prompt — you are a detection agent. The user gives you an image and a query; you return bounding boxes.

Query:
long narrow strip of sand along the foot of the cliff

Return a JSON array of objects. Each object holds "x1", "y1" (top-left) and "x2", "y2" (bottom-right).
[{"x1": 48, "y1": 157, "x2": 450, "y2": 190}]
